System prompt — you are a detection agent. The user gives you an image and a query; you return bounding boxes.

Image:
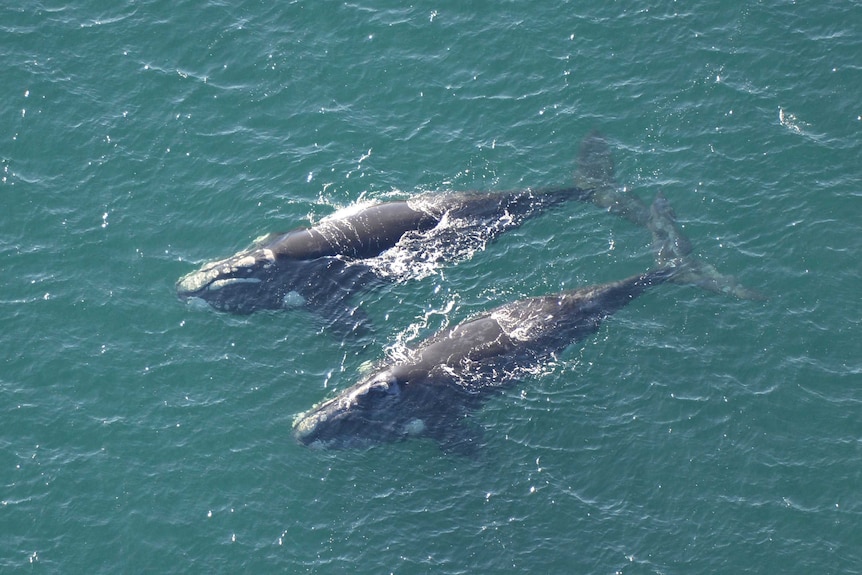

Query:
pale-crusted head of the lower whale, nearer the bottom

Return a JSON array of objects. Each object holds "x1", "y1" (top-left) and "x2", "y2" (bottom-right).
[{"x1": 293, "y1": 370, "x2": 432, "y2": 449}]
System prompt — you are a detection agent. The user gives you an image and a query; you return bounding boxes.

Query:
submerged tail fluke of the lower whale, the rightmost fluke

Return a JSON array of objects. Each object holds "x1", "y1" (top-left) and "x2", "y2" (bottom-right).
[{"x1": 646, "y1": 192, "x2": 766, "y2": 300}]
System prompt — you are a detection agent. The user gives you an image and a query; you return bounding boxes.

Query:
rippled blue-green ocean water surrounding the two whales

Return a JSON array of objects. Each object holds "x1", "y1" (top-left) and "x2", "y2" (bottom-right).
[{"x1": 0, "y1": 0, "x2": 862, "y2": 575}]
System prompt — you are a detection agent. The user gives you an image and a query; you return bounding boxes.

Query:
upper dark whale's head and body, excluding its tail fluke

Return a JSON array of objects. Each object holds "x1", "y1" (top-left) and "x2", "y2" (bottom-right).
[{"x1": 176, "y1": 186, "x2": 592, "y2": 325}]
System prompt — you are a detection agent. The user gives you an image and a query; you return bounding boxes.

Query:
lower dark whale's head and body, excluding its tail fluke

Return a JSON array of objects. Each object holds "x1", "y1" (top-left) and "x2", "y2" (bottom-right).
[{"x1": 293, "y1": 265, "x2": 682, "y2": 454}]
